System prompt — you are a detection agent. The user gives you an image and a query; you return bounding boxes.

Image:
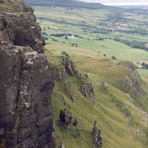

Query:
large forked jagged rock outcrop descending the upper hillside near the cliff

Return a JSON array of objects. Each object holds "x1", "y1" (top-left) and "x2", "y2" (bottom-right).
[{"x1": 55, "y1": 52, "x2": 96, "y2": 103}]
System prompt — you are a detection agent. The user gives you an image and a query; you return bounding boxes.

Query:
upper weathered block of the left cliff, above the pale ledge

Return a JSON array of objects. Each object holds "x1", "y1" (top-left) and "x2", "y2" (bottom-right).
[{"x1": 0, "y1": 1, "x2": 45, "y2": 53}]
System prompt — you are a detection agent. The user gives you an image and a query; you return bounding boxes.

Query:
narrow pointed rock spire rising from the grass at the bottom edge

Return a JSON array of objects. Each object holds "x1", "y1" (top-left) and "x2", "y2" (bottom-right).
[{"x1": 91, "y1": 121, "x2": 103, "y2": 148}]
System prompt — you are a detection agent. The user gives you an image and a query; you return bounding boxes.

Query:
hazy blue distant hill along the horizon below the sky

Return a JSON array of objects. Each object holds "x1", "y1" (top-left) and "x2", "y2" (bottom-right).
[{"x1": 24, "y1": 0, "x2": 107, "y2": 9}]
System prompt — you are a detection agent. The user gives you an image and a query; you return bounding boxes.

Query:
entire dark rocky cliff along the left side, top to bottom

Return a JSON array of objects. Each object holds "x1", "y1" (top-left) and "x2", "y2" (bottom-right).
[{"x1": 0, "y1": 0, "x2": 54, "y2": 148}]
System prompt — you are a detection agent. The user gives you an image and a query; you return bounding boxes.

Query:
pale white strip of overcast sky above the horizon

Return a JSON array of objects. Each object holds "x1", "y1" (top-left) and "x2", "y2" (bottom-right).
[{"x1": 80, "y1": 0, "x2": 148, "y2": 5}]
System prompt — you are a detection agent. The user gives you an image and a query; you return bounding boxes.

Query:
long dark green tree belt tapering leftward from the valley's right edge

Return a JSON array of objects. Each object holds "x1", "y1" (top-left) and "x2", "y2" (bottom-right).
[{"x1": 114, "y1": 38, "x2": 148, "y2": 50}]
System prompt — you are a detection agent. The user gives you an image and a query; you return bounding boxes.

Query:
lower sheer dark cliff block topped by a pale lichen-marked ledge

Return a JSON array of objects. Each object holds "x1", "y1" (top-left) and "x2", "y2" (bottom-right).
[{"x1": 0, "y1": 45, "x2": 54, "y2": 148}]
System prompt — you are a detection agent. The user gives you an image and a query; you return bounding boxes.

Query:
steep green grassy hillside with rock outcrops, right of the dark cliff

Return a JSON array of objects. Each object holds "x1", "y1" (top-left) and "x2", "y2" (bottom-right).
[{"x1": 45, "y1": 49, "x2": 148, "y2": 148}]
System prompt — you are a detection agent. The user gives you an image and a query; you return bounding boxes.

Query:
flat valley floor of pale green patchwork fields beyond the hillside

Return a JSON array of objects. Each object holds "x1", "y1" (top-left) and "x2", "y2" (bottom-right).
[{"x1": 34, "y1": 6, "x2": 148, "y2": 68}]
